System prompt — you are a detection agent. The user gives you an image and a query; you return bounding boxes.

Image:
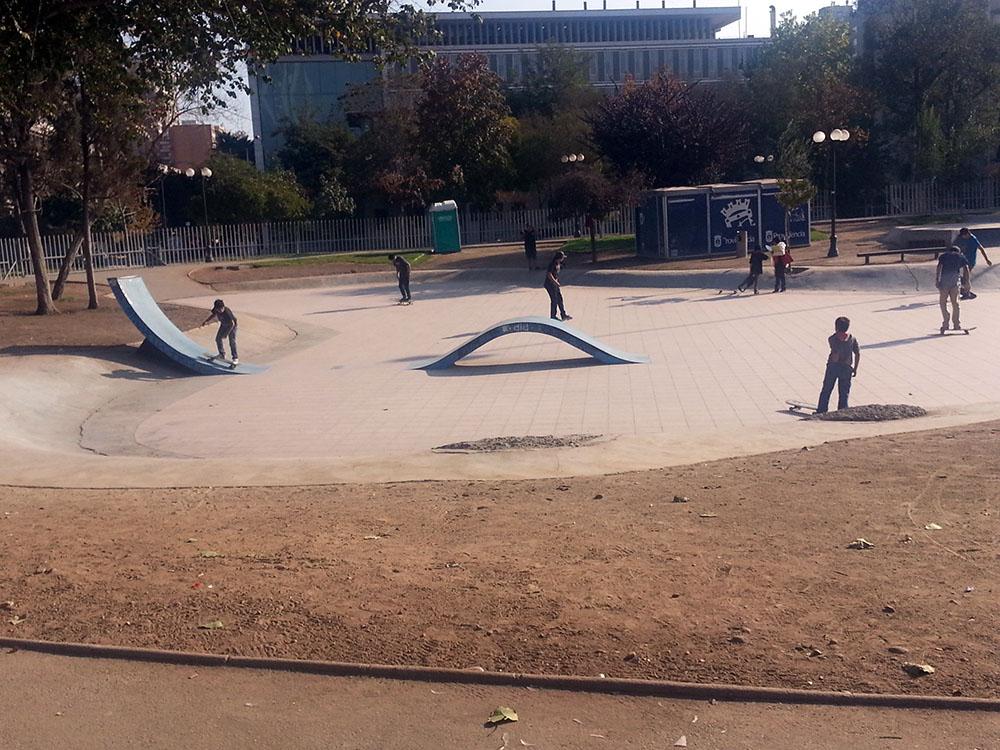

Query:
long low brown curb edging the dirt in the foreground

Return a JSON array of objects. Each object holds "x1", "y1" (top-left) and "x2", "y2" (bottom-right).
[{"x1": 0, "y1": 638, "x2": 1000, "y2": 712}]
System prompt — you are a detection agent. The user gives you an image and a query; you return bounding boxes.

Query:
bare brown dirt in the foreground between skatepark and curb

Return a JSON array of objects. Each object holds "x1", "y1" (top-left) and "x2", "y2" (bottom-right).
[{"x1": 0, "y1": 423, "x2": 1000, "y2": 697}]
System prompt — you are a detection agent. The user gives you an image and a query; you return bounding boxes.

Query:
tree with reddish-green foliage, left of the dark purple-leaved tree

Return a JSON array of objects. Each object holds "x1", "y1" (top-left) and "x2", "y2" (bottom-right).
[{"x1": 416, "y1": 55, "x2": 513, "y2": 209}]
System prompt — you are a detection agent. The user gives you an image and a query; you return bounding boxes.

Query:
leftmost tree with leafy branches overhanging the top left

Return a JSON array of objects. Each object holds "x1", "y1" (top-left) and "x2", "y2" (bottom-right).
[{"x1": 0, "y1": 0, "x2": 465, "y2": 313}]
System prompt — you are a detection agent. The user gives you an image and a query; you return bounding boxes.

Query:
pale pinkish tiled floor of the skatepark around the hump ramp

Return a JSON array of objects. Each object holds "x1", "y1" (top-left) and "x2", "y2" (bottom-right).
[{"x1": 136, "y1": 281, "x2": 1000, "y2": 458}]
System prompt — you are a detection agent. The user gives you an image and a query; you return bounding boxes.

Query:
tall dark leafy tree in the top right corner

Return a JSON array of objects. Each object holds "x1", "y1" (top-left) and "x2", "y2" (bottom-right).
[{"x1": 861, "y1": 0, "x2": 1000, "y2": 179}]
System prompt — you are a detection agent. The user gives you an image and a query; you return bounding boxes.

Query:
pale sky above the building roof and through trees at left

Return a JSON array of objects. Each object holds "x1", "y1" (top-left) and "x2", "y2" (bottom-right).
[{"x1": 205, "y1": 0, "x2": 844, "y2": 133}]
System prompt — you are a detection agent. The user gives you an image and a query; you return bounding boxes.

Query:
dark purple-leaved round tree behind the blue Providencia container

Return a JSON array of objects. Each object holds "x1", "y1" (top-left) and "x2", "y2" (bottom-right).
[{"x1": 588, "y1": 73, "x2": 747, "y2": 187}]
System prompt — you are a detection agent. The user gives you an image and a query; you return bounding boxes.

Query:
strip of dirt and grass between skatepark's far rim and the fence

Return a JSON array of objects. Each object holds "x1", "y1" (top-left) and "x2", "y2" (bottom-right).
[{"x1": 192, "y1": 220, "x2": 916, "y2": 285}]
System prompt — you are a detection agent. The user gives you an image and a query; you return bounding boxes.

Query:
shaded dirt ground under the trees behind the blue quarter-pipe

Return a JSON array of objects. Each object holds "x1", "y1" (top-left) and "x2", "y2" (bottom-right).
[{"x1": 0, "y1": 283, "x2": 207, "y2": 352}]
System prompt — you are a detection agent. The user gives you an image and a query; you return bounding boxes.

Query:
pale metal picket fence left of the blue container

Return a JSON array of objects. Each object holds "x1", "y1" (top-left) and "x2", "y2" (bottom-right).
[{"x1": 0, "y1": 209, "x2": 633, "y2": 280}]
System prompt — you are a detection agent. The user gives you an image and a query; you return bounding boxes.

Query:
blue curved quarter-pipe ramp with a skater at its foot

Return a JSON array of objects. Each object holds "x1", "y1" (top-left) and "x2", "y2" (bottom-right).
[{"x1": 108, "y1": 276, "x2": 267, "y2": 375}]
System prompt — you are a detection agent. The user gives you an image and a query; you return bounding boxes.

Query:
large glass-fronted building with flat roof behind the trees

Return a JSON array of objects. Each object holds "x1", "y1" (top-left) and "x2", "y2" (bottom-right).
[{"x1": 250, "y1": 7, "x2": 768, "y2": 166}]
